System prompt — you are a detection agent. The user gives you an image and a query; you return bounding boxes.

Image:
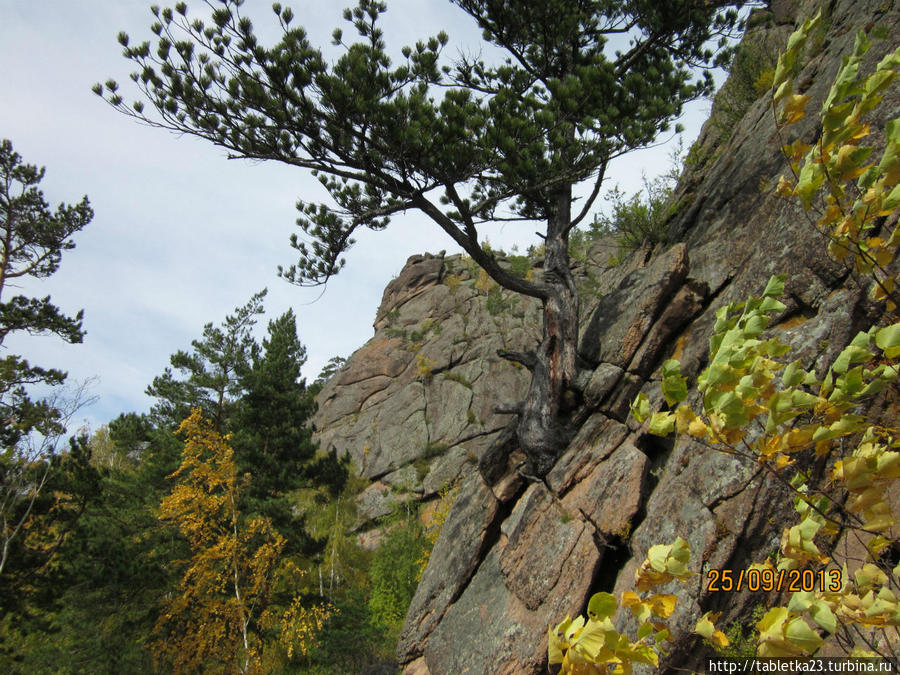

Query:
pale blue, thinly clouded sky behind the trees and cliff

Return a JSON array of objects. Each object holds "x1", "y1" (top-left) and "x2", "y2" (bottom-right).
[{"x1": 0, "y1": 0, "x2": 709, "y2": 429}]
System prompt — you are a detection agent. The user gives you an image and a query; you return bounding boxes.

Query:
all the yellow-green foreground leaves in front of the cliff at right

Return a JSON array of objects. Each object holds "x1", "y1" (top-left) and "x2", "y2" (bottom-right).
[{"x1": 560, "y1": 15, "x2": 900, "y2": 674}]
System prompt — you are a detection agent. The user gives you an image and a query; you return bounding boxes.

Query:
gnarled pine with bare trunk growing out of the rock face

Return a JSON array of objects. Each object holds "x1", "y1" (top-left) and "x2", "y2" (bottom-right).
[{"x1": 100, "y1": 0, "x2": 741, "y2": 474}]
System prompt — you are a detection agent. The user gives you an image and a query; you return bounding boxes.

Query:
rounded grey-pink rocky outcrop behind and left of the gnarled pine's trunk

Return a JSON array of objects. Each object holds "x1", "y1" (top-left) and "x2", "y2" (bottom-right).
[{"x1": 314, "y1": 254, "x2": 540, "y2": 510}]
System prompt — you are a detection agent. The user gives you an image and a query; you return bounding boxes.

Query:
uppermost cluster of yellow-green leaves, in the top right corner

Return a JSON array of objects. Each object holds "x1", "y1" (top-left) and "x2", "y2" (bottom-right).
[{"x1": 773, "y1": 16, "x2": 900, "y2": 312}]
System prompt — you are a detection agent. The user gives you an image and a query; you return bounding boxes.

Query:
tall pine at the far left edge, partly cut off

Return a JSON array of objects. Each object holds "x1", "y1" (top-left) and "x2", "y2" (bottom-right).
[{"x1": 0, "y1": 140, "x2": 96, "y2": 591}]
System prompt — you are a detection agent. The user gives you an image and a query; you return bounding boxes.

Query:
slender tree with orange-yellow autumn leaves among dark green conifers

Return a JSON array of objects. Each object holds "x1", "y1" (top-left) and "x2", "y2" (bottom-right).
[{"x1": 153, "y1": 410, "x2": 327, "y2": 673}]
